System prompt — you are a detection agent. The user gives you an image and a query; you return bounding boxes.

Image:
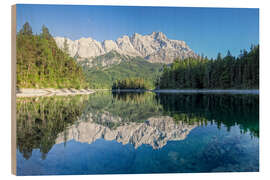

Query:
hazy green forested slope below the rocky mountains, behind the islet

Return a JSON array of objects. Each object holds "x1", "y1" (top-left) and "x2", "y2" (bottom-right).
[{"x1": 81, "y1": 52, "x2": 162, "y2": 89}]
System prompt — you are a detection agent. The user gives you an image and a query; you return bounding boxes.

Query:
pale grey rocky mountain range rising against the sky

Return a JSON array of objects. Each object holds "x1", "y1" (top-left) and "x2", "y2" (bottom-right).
[{"x1": 54, "y1": 32, "x2": 197, "y2": 65}]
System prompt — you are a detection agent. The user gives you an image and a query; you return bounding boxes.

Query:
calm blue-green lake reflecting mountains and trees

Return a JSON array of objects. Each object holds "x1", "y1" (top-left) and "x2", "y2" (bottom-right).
[{"x1": 16, "y1": 91, "x2": 259, "y2": 175}]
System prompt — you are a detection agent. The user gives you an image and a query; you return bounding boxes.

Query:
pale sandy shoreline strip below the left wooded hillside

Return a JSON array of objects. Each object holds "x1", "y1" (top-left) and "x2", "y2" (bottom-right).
[{"x1": 16, "y1": 88, "x2": 96, "y2": 97}]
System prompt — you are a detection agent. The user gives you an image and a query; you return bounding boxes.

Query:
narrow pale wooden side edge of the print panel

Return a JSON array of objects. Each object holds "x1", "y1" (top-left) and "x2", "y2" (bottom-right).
[{"x1": 11, "y1": 5, "x2": 17, "y2": 175}]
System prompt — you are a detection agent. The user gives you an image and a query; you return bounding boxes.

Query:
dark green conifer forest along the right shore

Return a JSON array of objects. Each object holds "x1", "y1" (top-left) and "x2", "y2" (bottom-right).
[{"x1": 156, "y1": 45, "x2": 259, "y2": 89}]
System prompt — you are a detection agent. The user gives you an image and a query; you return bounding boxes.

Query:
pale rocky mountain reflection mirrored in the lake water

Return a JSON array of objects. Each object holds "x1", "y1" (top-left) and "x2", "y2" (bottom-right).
[{"x1": 56, "y1": 114, "x2": 196, "y2": 149}]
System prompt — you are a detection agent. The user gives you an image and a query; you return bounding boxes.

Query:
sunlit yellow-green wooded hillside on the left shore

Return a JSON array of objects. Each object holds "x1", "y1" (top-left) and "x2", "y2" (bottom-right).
[{"x1": 16, "y1": 23, "x2": 87, "y2": 89}]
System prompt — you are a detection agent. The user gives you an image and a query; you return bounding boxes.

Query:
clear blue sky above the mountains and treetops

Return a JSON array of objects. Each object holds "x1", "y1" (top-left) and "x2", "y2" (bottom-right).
[{"x1": 17, "y1": 4, "x2": 259, "y2": 57}]
